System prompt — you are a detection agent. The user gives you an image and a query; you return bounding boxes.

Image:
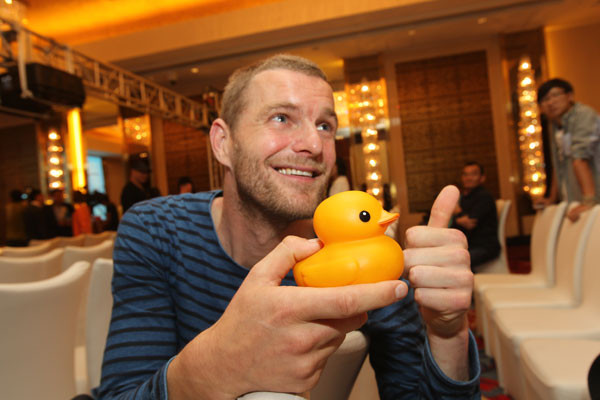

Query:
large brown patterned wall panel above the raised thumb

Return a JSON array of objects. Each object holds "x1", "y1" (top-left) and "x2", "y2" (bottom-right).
[{"x1": 396, "y1": 51, "x2": 499, "y2": 212}]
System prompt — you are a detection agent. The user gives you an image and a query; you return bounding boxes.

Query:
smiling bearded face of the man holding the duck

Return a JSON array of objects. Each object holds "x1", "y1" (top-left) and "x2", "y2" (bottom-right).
[{"x1": 231, "y1": 69, "x2": 337, "y2": 221}]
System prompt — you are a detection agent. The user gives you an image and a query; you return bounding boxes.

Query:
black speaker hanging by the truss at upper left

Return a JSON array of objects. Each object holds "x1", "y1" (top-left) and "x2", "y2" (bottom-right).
[{"x1": 0, "y1": 63, "x2": 85, "y2": 112}]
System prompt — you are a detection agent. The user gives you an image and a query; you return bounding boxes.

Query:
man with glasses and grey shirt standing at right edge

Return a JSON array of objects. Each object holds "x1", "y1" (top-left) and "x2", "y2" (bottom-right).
[{"x1": 538, "y1": 79, "x2": 600, "y2": 221}]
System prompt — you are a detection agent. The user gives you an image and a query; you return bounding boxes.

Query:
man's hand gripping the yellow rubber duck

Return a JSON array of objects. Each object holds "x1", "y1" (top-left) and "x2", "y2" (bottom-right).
[{"x1": 167, "y1": 236, "x2": 408, "y2": 400}]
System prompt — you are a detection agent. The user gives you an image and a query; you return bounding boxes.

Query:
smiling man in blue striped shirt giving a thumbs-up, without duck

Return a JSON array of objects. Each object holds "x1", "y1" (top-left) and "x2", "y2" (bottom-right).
[{"x1": 96, "y1": 55, "x2": 479, "y2": 400}]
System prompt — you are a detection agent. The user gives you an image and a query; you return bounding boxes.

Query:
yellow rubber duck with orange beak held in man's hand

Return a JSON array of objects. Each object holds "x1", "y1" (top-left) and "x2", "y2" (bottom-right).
[{"x1": 294, "y1": 190, "x2": 404, "y2": 287}]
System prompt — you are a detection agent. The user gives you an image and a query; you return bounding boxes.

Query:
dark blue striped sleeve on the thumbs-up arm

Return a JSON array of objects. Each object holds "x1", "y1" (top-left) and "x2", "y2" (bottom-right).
[{"x1": 363, "y1": 282, "x2": 480, "y2": 400}]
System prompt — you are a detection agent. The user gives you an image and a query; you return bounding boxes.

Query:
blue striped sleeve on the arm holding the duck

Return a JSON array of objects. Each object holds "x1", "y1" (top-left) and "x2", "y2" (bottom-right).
[{"x1": 94, "y1": 207, "x2": 177, "y2": 399}]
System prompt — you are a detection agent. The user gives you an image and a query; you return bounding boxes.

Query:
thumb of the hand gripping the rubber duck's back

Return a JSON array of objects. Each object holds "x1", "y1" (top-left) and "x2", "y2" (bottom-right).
[{"x1": 246, "y1": 236, "x2": 322, "y2": 286}]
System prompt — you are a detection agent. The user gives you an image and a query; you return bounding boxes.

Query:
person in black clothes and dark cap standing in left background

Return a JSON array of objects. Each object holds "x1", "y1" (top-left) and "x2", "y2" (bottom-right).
[{"x1": 121, "y1": 153, "x2": 153, "y2": 214}]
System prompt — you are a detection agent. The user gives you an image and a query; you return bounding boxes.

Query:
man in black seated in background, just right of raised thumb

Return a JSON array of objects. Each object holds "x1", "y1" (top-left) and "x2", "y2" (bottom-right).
[{"x1": 452, "y1": 162, "x2": 500, "y2": 272}]
